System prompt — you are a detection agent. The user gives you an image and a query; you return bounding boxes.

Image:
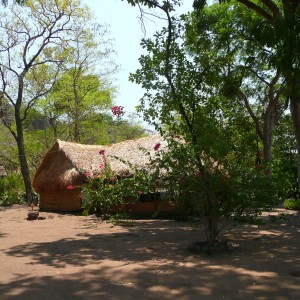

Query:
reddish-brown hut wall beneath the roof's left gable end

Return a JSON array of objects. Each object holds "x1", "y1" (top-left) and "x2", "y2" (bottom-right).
[{"x1": 40, "y1": 189, "x2": 82, "y2": 211}]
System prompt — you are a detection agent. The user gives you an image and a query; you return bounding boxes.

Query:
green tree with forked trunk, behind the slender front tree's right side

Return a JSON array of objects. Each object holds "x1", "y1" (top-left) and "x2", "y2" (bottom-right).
[{"x1": 186, "y1": 3, "x2": 287, "y2": 169}]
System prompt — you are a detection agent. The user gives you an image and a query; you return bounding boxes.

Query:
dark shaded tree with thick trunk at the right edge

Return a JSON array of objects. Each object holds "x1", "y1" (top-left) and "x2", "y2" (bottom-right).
[{"x1": 230, "y1": 0, "x2": 300, "y2": 188}]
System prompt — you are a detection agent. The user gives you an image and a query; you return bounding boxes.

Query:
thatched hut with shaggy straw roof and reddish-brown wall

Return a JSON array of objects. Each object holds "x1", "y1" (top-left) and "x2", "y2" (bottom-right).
[{"x1": 33, "y1": 135, "x2": 167, "y2": 211}]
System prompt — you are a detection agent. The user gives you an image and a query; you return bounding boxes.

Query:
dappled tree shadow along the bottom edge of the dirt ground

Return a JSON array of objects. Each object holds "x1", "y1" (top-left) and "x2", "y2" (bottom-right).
[{"x1": 0, "y1": 262, "x2": 300, "y2": 300}]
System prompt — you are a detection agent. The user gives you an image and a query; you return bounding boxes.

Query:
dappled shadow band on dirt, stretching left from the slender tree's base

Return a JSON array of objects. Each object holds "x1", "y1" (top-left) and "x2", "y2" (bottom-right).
[{"x1": 6, "y1": 221, "x2": 202, "y2": 268}]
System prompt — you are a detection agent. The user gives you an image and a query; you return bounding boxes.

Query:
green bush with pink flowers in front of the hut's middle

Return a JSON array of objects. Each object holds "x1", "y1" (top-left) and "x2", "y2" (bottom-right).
[{"x1": 67, "y1": 150, "x2": 149, "y2": 219}]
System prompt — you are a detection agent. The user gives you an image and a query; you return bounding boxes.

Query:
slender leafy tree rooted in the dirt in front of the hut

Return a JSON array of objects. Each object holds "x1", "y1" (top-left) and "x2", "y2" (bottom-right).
[{"x1": 131, "y1": 3, "x2": 234, "y2": 245}]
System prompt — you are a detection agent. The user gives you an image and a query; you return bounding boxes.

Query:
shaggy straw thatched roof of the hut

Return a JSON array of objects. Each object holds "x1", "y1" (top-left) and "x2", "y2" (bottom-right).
[{"x1": 33, "y1": 135, "x2": 167, "y2": 192}]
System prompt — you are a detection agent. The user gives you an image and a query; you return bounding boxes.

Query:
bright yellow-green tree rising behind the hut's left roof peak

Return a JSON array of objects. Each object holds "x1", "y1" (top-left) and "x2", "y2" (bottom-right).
[{"x1": 44, "y1": 69, "x2": 113, "y2": 142}]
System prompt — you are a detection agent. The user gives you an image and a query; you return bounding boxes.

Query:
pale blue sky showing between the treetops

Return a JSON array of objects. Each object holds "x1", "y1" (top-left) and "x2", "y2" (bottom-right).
[{"x1": 82, "y1": 0, "x2": 193, "y2": 125}]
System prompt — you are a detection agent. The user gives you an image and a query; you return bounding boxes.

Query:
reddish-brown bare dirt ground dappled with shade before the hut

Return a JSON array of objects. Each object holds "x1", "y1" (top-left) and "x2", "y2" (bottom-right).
[{"x1": 0, "y1": 206, "x2": 300, "y2": 300}]
